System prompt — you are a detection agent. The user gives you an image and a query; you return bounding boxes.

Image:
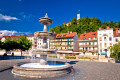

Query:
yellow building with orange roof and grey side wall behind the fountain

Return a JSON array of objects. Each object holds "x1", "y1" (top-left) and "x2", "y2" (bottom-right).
[{"x1": 50, "y1": 31, "x2": 79, "y2": 55}]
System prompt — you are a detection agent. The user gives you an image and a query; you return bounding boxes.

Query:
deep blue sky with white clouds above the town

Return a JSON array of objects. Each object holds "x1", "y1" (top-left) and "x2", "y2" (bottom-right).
[{"x1": 0, "y1": 0, "x2": 120, "y2": 37}]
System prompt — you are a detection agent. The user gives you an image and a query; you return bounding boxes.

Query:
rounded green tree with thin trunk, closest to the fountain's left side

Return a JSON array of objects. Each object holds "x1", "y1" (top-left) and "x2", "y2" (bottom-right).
[{"x1": 18, "y1": 37, "x2": 32, "y2": 56}]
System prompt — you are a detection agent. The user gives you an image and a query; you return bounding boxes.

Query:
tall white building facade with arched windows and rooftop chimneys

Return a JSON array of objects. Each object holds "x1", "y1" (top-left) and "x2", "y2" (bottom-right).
[{"x1": 97, "y1": 26, "x2": 114, "y2": 57}]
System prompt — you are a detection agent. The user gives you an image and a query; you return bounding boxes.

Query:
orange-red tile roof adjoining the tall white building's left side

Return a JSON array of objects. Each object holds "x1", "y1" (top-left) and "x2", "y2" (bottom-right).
[{"x1": 79, "y1": 32, "x2": 97, "y2": 40}]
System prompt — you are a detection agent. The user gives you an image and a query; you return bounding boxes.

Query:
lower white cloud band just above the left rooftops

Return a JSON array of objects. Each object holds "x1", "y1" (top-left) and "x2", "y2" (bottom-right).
[{"x1": 0, "y1": 30, "x2": 31, "y2": 37}]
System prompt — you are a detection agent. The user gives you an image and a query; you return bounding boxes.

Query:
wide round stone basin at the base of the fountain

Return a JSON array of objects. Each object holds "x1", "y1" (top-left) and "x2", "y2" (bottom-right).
[{"x1": 12, "y1": 63, "x2": 73, "y2": 78}]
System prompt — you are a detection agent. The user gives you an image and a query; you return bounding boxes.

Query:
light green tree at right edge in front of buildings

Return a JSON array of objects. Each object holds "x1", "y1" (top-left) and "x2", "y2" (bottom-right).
[{"x1": 110, "y1": 42, "x2": 120, "y2": 59}]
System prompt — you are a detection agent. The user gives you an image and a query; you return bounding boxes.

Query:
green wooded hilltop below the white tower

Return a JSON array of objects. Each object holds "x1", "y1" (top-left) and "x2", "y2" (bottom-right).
[{"x1": 50, "y1": 17, "x2": 120, "y2": 36}]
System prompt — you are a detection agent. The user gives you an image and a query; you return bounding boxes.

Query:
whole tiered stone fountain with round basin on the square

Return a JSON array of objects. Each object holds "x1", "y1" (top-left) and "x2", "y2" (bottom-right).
[{"x1": 12, "y1": 14, "x2": 72, "y2": 78}]
